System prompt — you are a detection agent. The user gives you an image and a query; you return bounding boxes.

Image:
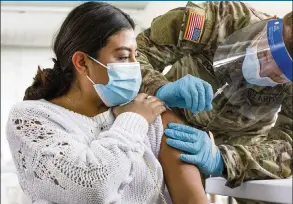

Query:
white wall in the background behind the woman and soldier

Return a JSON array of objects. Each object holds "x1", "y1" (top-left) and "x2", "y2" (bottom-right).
[{"x1": 1, "y1": 1, "x2": 292, "y2": 204}]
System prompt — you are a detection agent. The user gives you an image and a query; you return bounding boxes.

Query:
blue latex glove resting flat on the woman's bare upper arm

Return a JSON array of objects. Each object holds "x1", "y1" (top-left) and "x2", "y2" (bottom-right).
[{"x1": 165, "y1": 123, "x2": 224, "y2": 176}]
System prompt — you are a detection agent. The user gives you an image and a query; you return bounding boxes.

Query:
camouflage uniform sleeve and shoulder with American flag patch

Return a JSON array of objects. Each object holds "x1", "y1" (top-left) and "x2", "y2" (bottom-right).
[{"x1": 137, "y1": 2, "x2": 267, "y2": 95}]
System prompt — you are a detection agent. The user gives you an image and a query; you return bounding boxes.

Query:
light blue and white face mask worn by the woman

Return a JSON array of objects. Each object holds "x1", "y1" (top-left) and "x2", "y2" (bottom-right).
[{"x1": 88, "y1": 56, "x2": 142, "y2": 107}]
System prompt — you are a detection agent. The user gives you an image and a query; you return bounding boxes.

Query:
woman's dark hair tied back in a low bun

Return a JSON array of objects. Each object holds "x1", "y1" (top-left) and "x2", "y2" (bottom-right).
[{"x1": 23, "y1": 2, "x2": 135, "y2": 100}]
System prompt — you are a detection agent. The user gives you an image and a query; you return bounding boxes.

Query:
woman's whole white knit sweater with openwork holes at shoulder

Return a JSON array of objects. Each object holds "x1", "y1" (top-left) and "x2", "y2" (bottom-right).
[{"x1": 7, "y1": 100, "x2": 165, "y2": 204}]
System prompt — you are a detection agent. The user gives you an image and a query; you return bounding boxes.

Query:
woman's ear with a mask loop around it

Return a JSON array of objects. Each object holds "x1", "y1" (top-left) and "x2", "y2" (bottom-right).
[{"x1": 71, "y1": 51, "x2": 89, "y2": 75}]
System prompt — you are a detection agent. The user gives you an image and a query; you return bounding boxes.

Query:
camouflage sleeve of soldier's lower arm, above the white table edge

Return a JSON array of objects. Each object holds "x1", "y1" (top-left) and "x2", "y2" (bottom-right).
[{"x1": 219, "y1": 83, "x2": 293, "y2": 187}]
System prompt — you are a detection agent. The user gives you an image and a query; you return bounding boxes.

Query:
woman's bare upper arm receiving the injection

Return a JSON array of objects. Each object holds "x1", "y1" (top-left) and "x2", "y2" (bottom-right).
[{"x1": 159, "y1": 111, "x2": 208, "y2": 204}]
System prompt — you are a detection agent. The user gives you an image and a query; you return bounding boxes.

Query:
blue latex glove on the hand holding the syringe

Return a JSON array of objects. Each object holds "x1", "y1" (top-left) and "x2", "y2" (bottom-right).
[{"x1": 156, "y1": 74, "x2": 214, "y2": 113}]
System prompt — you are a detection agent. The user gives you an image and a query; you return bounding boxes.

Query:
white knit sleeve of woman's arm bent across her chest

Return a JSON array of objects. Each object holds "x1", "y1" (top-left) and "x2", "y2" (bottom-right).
[{"x1": 7, "y1": 105, "x2": 148, "y2": 204}]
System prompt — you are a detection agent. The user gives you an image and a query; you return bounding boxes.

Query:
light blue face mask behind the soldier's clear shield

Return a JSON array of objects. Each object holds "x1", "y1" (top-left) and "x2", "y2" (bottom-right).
[{"x1": 242, "y1": 46, "x2": 280, "y2": 87}]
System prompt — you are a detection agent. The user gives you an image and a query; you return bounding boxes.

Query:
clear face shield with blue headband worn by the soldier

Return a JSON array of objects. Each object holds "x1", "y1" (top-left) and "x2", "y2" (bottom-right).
[{"x1": 213, "y1": 19, "x2": 293, "y2": 119}]
